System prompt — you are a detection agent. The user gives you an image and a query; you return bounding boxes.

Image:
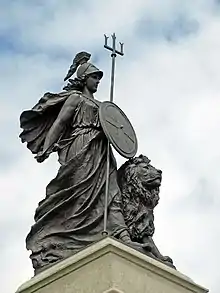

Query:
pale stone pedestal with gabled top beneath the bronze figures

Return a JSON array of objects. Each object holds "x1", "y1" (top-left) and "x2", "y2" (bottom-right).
[{"x1": 16, "y1": 238, "x2": 208, "y2": 293}]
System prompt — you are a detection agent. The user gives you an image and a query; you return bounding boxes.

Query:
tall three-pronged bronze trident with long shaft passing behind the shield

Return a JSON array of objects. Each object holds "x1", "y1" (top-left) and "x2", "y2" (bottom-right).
[{"x1": 102, "y1": 33, "x2": 124, "y2": 236}]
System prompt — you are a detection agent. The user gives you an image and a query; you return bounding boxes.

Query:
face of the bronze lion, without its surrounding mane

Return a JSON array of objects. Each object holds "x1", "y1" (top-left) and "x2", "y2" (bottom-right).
[{"x1": 137, "y1": 162, "x2": 162, "y2": 189}]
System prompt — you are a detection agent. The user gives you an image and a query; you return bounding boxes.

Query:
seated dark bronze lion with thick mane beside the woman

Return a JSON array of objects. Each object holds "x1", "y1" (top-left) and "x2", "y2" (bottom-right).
[{"x1": 118, "y1": 155, "x2": 175, "y2": 268}]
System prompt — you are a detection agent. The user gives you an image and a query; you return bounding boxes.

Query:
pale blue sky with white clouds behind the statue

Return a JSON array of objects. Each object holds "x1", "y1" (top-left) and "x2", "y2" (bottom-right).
[{"x1": 0, "y1": 0, "x2": 220, "y2": 293}]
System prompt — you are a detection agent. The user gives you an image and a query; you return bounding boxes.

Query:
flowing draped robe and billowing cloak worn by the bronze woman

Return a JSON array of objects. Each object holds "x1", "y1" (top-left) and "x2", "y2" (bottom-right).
[{"x1": 20, "y1": 93, "x2": 127, "y2": 273}]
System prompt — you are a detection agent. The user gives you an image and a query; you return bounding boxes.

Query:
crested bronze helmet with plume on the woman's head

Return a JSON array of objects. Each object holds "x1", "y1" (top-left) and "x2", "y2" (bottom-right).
[{"x1": 64, "y1": 52, "x2": 103, "y2": 81}]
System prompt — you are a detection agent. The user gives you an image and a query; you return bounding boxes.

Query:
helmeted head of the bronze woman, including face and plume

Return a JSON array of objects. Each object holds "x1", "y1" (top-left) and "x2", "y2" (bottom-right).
[{"x1": 64, "y1": 52, "x2": 103, "y2": 93}]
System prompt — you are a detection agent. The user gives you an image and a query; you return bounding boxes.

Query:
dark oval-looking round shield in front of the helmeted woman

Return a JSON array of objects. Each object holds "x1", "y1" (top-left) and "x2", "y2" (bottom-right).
[{"x1": 99, "y1": 102, "x2": 137, "y2": 159}]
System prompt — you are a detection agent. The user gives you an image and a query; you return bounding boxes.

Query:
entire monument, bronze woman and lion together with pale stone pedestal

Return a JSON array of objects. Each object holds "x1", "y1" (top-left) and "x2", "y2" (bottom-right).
[{"x1": 18, "y1": 34, "x2": 207, "y2": 293}]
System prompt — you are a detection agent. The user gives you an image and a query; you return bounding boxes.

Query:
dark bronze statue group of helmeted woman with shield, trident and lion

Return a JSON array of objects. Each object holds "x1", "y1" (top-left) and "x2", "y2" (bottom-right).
[{"x1": 20, "y1": 35, "x2": 174, "y2": 274}]
